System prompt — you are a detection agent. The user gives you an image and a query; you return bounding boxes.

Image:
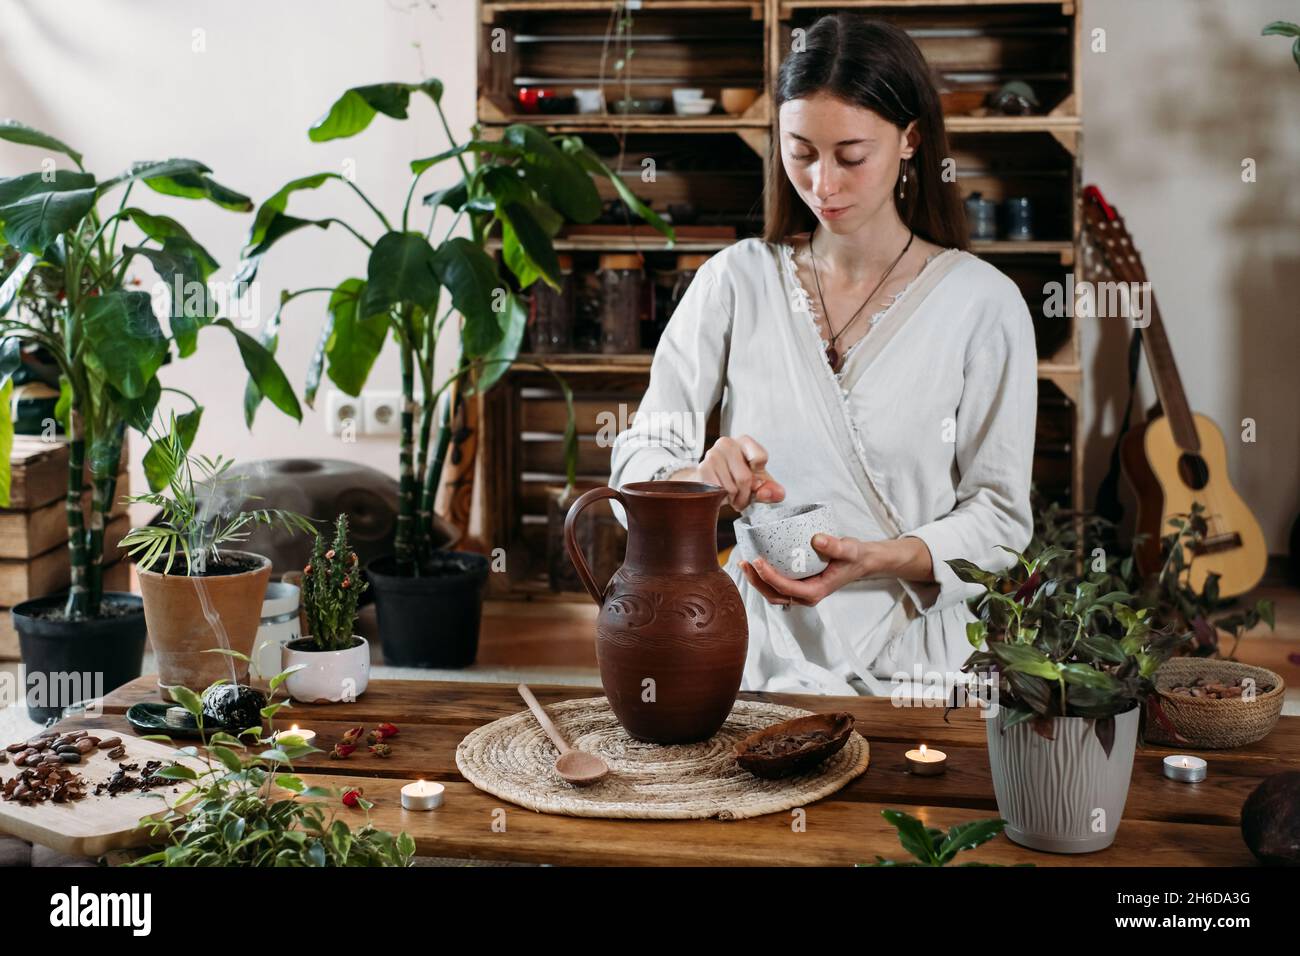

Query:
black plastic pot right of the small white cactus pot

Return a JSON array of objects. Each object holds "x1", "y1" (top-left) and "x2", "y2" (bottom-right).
[{"x1": 365, "y1": 551, "x2": 488, "y2": 667}]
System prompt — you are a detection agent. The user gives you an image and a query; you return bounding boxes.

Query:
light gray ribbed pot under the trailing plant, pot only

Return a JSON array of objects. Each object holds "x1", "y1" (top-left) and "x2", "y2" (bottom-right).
[{"x1": 987, "y1": 706, "x2": 1140, "y2": 853}]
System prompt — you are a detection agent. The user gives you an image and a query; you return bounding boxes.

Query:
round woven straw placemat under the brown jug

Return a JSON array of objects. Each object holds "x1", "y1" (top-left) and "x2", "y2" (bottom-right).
[{"x1": 456, "y1": 697, "x2": 870, "y2": 819}]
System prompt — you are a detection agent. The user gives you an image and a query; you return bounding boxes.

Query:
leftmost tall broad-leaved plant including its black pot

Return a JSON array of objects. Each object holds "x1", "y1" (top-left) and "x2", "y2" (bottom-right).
[{"x1": 0, "y1": 120, "x2": 302, "y2": 721}]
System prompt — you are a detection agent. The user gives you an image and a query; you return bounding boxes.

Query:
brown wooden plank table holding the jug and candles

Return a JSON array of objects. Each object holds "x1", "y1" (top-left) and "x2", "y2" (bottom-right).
[{"x1": 48, "y1": 676, "x2": 1300, "y2": 866}]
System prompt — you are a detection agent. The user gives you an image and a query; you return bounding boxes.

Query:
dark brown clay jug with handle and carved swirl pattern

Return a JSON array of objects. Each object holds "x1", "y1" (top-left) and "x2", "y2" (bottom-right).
[{"x1": 564, "y1": 481, "x2": 749, "y2": 744}]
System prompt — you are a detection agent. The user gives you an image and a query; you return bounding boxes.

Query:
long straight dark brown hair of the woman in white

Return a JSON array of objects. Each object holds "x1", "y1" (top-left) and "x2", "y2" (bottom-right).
[{"x1": 763, "y1": 13, "x2": 969, "y2": 248}]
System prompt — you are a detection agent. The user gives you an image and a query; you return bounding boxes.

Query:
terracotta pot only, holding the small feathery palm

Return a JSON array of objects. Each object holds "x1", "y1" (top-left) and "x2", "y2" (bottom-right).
[{"x1": 137, "y1": 551, "x2": 270, "y2": 697}]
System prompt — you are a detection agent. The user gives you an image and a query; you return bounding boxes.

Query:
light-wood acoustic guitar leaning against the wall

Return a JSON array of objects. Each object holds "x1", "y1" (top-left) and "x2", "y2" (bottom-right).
[{"x1": 1083, "y1": 186, "x2": 1269, "y2": 597}]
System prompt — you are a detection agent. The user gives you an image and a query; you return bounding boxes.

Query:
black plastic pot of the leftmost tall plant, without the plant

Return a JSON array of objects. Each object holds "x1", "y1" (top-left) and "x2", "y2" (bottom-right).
[{"x1": 13, "y1": 592, "x2": 146, "y2": 723}]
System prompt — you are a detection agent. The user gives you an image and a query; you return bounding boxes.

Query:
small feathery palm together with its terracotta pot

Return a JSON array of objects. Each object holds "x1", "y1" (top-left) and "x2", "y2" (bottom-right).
[{"x1": 122, "y1": 415, "x2": 316, "y2": 693}]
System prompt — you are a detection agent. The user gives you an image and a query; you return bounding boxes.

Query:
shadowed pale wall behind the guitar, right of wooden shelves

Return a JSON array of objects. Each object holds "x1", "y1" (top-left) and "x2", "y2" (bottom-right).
[{"x1": 1083, "y1": 0, "x2": 1300, "y2": 554}]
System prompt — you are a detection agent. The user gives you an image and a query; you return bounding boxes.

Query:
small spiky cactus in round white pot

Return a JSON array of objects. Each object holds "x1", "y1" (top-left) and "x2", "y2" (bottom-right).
[{"x1": 283, "y1": 514, "x2": 371, "y2": 704}]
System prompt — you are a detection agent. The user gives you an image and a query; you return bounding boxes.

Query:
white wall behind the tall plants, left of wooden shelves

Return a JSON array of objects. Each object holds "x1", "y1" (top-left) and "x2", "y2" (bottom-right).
[{"x1": 0, "y1": 0, "x2": 475, "y2": 522}]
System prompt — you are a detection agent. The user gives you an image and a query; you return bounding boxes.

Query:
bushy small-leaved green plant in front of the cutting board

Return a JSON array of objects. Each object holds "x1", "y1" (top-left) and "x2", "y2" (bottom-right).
[{"x1": 131, "y1": 671, "x2": 415, "y2": 866}]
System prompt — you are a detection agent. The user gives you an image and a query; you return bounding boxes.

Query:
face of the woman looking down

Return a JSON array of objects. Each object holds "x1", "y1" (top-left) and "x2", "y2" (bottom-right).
[{"x1": 780, "y1": 92, "x2": 915, "y2": 233}]
